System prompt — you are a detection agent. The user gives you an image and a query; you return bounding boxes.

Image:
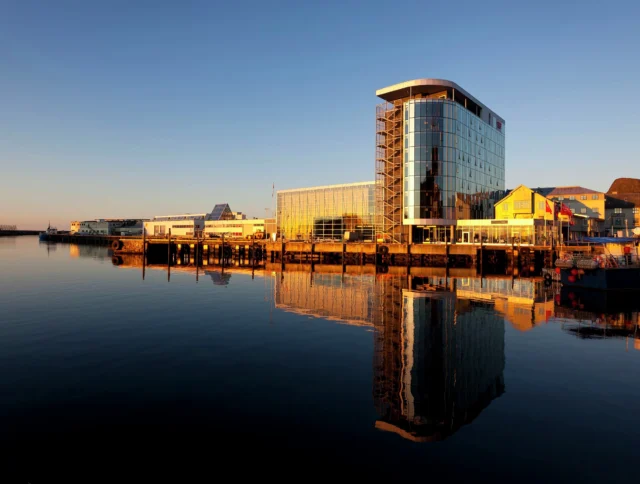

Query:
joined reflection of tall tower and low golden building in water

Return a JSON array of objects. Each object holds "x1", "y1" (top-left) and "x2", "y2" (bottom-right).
[{"x1": 274, "y1": 272, "x2": 516, "y2": 442}]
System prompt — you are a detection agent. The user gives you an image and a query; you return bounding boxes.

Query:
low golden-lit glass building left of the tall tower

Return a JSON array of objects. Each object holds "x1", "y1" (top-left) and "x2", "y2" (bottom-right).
[{"x1": 276, "y1": 182, "x2": 375, "y2": 241}]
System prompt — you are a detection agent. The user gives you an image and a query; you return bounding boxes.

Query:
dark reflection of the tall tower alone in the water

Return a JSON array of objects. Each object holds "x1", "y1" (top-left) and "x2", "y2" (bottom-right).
[{"x1": 374, "y1": 290, "x2": 505, "y2": 442}]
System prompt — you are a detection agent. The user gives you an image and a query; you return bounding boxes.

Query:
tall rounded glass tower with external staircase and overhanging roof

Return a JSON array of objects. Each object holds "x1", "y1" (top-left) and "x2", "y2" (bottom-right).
[{"x1": 376, "y1": 79, "x2": 505, "y2": 243}]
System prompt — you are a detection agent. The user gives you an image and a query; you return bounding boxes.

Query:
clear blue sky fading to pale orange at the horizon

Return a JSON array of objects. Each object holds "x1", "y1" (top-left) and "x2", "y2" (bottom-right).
[{"x1": 0, "y1": 0, "x2": 640, "y2": 228}]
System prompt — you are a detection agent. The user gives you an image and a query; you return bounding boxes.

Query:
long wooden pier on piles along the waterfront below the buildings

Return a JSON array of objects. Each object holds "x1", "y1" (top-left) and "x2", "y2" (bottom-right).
[{"x1": 45, "y1": 234, "x2": 595, "y2": 275}]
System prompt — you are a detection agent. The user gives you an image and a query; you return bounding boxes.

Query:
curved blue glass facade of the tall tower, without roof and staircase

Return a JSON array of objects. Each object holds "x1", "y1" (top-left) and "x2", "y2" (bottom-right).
[{"x1": 403, "y1": 99, "x2": 505, "y2": 225}]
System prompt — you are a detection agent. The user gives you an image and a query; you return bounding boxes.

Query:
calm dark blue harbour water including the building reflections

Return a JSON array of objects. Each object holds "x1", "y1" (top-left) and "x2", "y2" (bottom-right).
[{"x1": 0, "y1": 237, "x2": 640, "y2": 482}]
